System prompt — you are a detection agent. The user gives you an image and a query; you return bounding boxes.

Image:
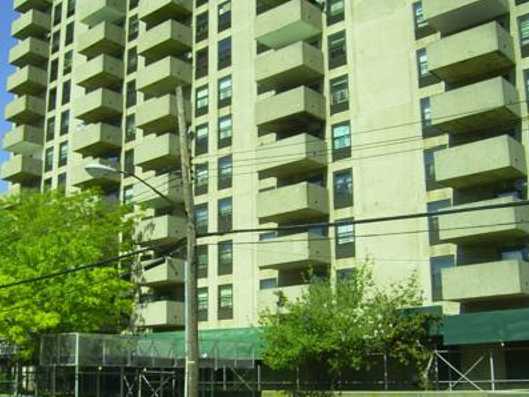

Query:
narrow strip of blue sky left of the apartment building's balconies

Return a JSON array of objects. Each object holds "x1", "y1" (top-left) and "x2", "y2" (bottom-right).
[{"x1": 0, "y1": 0, "x2": 16, "y2": 193}]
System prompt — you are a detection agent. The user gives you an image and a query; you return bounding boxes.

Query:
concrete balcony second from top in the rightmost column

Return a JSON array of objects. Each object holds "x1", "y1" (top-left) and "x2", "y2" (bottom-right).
[{"x1": 426, "y1": 22, "x2": 515, "y2": 84}]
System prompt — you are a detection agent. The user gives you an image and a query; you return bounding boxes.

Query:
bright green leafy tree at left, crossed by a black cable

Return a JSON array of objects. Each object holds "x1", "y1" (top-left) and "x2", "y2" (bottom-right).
[{"x1": 0, "y1": 191, "x2": 138, "y2": 359}]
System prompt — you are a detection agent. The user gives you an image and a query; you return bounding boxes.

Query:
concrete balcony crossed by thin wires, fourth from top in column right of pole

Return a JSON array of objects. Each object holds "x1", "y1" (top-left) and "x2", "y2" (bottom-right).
[{"x1": 255, "y1": 134, "x2": 327, "y2": 178}]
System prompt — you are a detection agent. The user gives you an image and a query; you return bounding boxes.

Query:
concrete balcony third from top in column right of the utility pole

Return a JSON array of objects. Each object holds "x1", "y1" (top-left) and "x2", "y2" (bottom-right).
[{"x1": 255, "y1": 87, "x2": 325, "y2": 133}]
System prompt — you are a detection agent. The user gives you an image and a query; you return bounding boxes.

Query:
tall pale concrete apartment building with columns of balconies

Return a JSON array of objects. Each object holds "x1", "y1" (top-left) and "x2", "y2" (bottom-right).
[{"x1": 1, "y1": 0, "x2": 529, "y2": 384}]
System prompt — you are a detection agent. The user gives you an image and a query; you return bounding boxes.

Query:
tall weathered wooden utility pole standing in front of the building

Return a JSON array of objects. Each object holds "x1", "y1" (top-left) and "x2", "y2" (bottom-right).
[{"x1": 176, "y1": 86, "x2": 199, "y2": 397}]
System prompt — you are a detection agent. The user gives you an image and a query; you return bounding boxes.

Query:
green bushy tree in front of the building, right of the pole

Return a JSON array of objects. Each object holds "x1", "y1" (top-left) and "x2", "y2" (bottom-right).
[{"x1": 260, "y1": 263, "x2": 435, "y2": 388}]
